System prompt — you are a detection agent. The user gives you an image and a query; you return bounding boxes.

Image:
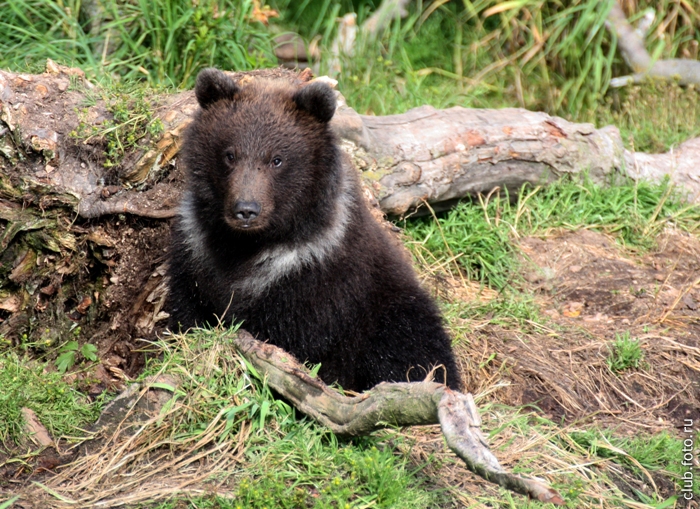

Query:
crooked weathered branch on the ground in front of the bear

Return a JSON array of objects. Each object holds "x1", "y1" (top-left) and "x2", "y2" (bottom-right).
[{"x1": 232, "y1": 331, "x2": 564, "y2": 505}]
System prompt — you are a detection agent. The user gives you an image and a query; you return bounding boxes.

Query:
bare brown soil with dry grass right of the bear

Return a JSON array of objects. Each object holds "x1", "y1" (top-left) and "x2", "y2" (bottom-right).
[{"x1": 464, "y1": 230, "x2": 700, "y2": 433}]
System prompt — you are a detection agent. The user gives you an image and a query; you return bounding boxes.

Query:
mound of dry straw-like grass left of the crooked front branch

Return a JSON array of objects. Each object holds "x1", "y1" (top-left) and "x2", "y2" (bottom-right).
[{"x1": 34, "y1": 336, "x2": 255, "y2": 508}]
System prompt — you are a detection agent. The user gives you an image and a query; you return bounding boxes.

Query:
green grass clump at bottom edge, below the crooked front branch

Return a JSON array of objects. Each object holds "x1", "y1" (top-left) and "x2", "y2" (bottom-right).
[{"x1": 231, "y1": 432, "x2": 440, "y2": 509}]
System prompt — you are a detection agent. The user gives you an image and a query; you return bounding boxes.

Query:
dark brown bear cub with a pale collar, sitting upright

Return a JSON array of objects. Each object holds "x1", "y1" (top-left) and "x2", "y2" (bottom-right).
[{"x1": 163, "y1": 69, "x2": 461, "y2": 391}]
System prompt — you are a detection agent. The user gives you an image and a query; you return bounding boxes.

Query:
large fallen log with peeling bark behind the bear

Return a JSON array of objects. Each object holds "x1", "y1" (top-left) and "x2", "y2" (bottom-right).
[{"x1": 0, "y1": 62, "x2": 700, "y2": 224}]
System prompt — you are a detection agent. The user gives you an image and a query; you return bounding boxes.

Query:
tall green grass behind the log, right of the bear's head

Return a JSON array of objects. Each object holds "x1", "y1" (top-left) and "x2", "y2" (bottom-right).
[{"x1": 273, "y1": 0, "x2": 700, "y2": 151}]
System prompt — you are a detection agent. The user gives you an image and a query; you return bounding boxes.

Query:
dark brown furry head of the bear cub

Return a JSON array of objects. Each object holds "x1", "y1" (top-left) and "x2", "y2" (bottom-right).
[{"x1": 182, "y1": 69, "x2": 339, "y2": 238}]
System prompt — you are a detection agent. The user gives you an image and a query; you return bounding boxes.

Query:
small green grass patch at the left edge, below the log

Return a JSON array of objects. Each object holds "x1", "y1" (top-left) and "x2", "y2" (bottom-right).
[{"x1": 0, "y1": 352, "x2": 101, "y2": 444}]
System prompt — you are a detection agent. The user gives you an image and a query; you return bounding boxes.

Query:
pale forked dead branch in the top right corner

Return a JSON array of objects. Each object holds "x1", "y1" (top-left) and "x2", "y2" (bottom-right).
[{"x1": 607, "y1": 2, "x2": 700, "y2": 87}]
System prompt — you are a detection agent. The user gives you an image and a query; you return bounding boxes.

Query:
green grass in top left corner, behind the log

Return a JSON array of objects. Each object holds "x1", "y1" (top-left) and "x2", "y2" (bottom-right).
[{"x1": 0, "y1": 0, "x2": 275, "y2": 87}]
